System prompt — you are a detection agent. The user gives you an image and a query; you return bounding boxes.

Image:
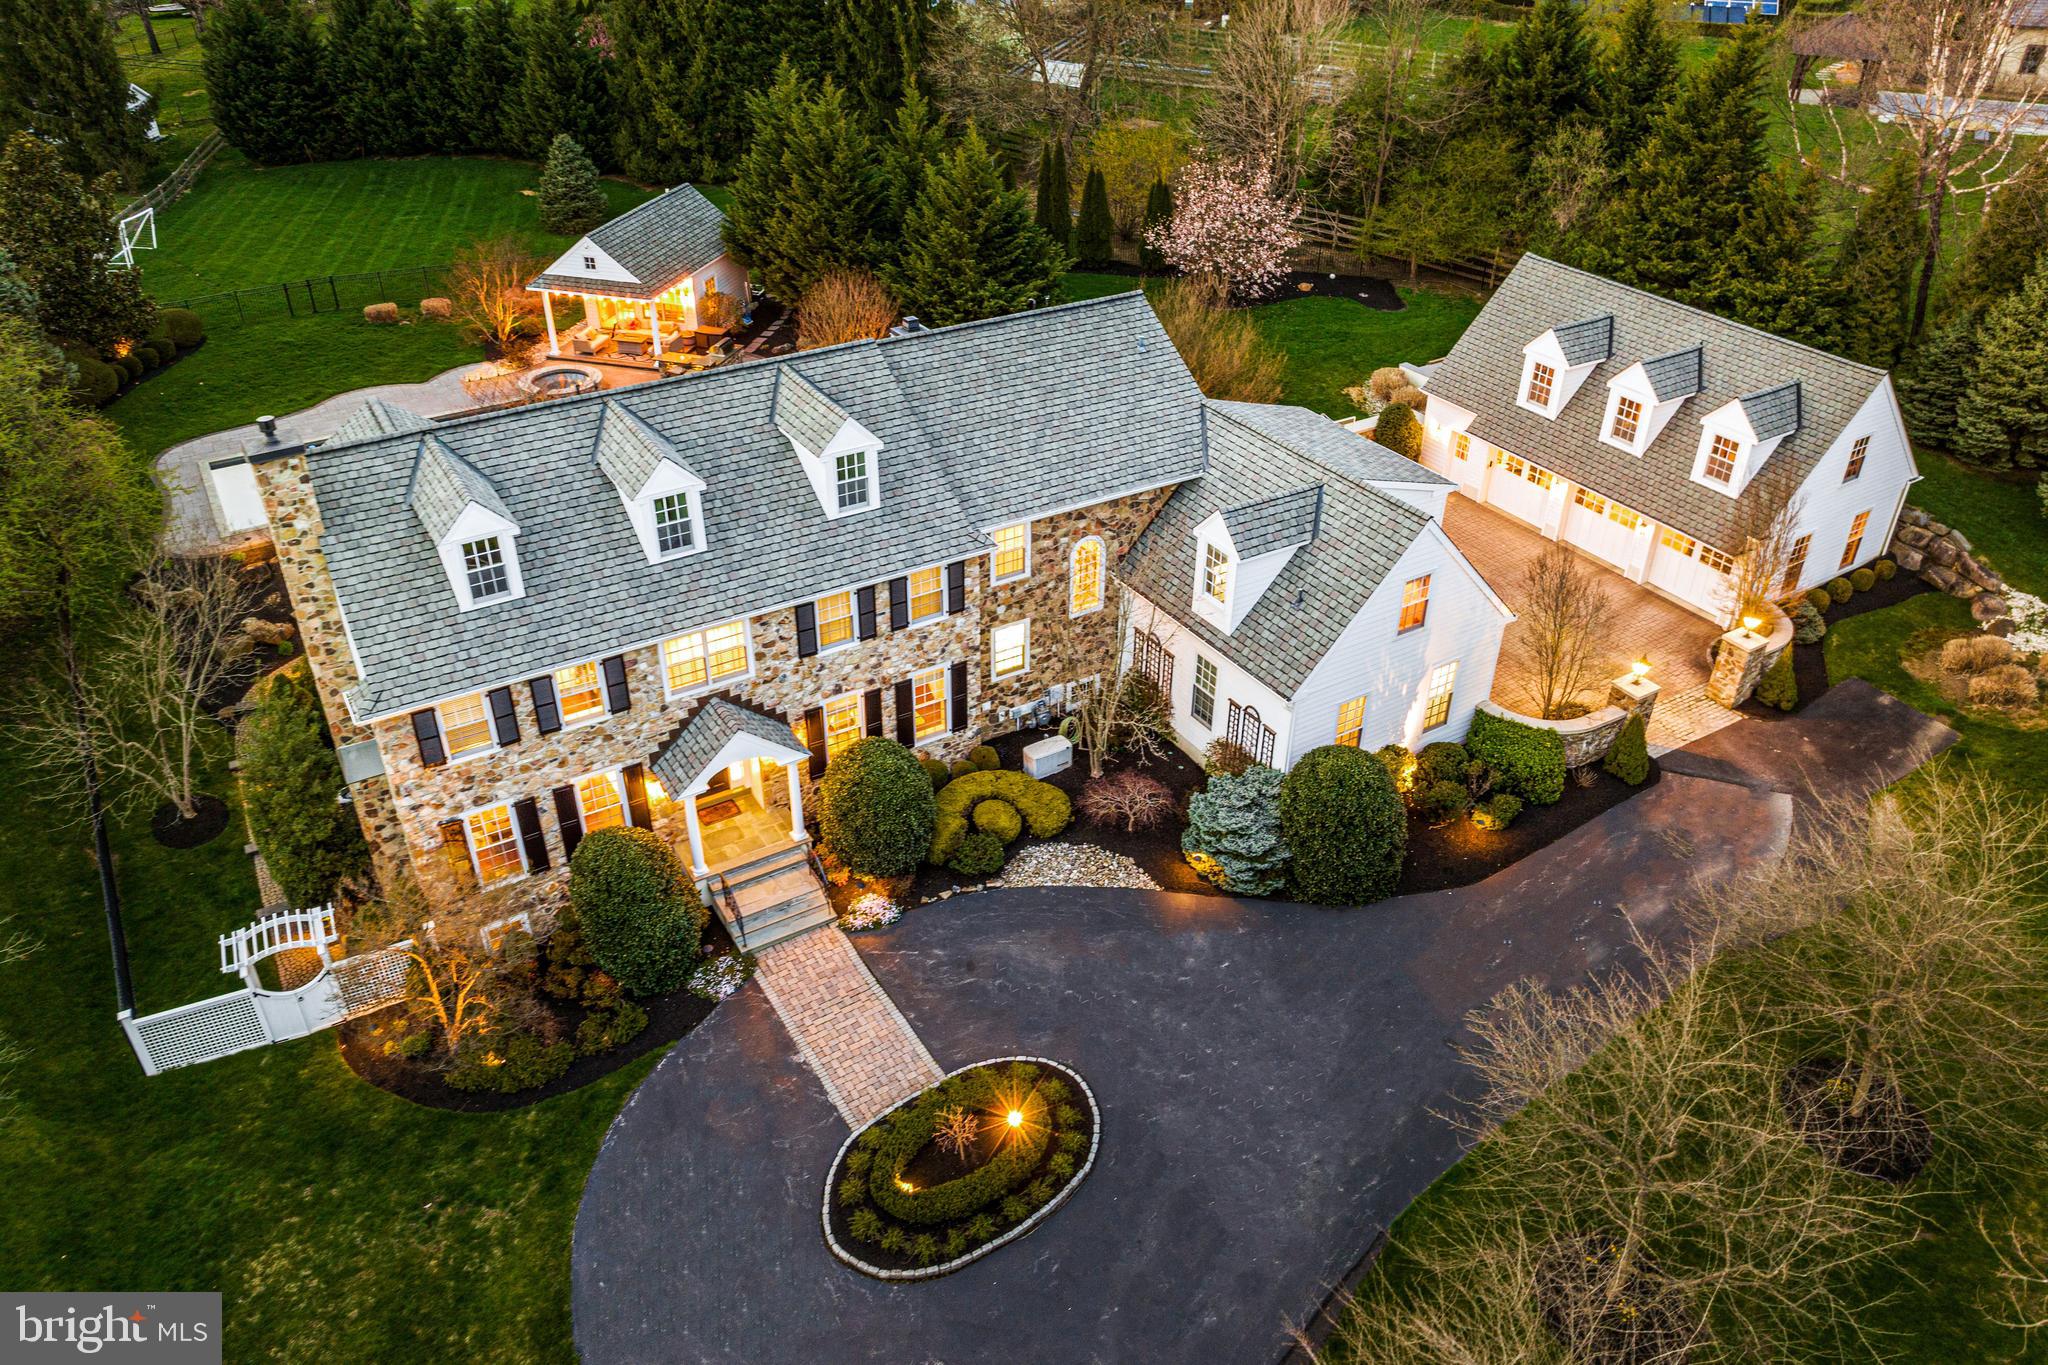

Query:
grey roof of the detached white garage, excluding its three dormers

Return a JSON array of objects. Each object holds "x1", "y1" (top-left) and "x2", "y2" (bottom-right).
[{"x1": 1430, "y1": 254, "x2": 1884, "y2": 553}]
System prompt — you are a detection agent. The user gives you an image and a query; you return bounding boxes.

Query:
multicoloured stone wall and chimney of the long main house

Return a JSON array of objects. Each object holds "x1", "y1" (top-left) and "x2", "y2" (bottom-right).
[{"x1": 256, "y1": 456, "x2": 1167, "y2": 913}]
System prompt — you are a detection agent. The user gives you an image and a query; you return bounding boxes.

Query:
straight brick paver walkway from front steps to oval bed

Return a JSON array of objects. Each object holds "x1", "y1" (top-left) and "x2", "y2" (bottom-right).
[{"x1": 756, "y1": 925, "x2": 942, "y2": 1128}]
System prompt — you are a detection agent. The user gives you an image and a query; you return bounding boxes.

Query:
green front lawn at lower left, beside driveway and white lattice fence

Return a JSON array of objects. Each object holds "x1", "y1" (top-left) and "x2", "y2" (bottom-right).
[{"x1": 0, "y1": 736, "x2": 651, "y2": 1363}]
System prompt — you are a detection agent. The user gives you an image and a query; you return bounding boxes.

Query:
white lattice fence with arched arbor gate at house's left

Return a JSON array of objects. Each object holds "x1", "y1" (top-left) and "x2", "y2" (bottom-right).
[{"x1": 119, "y1": 905, "x2": 412, "y2": 1076}]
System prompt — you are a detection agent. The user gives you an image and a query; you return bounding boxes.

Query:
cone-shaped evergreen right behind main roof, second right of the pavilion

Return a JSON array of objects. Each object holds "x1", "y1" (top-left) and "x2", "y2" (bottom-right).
[{"x1": 883, "y1": 127, "x2": 1067, "y2": 327}]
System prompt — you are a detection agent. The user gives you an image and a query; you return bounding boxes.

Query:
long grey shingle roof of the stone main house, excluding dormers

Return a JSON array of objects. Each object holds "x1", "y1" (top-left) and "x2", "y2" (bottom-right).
[{"x1": 296, "y1": 291, "x2": 1204, "y2": 718}]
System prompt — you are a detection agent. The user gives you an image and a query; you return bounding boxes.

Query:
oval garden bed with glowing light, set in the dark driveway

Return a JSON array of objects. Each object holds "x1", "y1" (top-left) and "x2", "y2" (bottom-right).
[{"x1": 823, "y1": 1056, "x2": 1102, "y2": 1279}]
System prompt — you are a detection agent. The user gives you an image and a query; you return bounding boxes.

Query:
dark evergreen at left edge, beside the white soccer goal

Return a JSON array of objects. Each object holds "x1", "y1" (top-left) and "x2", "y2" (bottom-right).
[{"x1": 0, "y1": 133, "x2": 156, "y2": 354}]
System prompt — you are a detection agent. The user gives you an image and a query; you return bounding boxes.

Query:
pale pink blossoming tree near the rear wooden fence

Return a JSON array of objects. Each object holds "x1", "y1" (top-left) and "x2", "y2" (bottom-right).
[{"x1": 1145, "y1": 160, "x2": 1300, "y2": 303}]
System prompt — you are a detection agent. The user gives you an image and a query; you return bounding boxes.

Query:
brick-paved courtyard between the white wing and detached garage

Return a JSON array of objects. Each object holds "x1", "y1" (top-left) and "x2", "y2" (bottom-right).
[{"x1": 1444, "y1": 493, "x2": 1741, "y2": 751}]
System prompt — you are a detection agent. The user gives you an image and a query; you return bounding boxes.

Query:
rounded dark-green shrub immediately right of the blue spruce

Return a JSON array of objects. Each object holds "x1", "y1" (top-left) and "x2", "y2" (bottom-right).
[{"x1": 1280, "y1": 745, "x2": 1409, "y2": 905}]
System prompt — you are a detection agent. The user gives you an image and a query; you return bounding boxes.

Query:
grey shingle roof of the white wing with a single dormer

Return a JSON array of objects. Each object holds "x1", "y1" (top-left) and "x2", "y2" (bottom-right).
[{"x1": 1122, "y1": 394, "x2": 1430, "y2": 696}]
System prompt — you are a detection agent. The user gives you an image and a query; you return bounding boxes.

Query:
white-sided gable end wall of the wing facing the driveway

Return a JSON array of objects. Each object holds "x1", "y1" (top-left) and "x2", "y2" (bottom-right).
[{"x1": 1288, "y1": 524, "x2": 1507, "y2": 761}]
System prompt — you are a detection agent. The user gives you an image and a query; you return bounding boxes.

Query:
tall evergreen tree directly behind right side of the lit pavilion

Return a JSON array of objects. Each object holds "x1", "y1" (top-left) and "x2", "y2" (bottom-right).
[{"x1": 725, "y1": 65, "x2": 885, "y2": 301}]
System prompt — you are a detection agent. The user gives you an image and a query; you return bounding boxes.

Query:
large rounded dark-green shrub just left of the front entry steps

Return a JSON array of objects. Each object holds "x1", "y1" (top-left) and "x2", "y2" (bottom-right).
[{"x1": 569, "y1": 827, "x2": 709, "y2": 995}]
